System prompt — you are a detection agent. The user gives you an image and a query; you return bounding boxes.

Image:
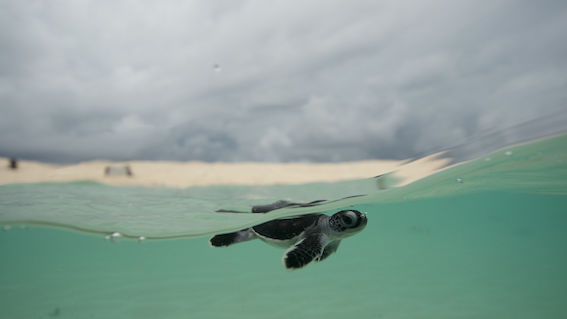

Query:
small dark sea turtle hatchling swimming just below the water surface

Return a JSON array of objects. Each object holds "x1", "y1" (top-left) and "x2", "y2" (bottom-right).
[{"x1": 210, "y1": 210, "x2": 368, "y2": 270}]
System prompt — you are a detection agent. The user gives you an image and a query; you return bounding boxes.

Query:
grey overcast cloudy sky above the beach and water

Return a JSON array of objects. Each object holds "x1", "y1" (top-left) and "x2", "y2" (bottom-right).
[{"x1": 0, "y1": 0, "x2": 567, "y2": 162}]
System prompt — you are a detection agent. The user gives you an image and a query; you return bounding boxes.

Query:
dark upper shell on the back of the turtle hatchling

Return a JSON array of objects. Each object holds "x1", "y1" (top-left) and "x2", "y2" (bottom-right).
[{"x1": 252, "y1": 214, "x2": 323, "y2": 240}]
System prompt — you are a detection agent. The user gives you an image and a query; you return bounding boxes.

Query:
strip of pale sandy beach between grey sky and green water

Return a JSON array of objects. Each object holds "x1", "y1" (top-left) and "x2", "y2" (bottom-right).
[{"x1": 0, "y1": 155, "x2": 449, "y2": 187}]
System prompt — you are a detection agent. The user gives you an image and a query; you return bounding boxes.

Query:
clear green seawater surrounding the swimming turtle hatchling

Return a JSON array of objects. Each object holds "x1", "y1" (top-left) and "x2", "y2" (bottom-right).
[{"x1": 0, "y1": 135, "x2": 567, "y2": 318}]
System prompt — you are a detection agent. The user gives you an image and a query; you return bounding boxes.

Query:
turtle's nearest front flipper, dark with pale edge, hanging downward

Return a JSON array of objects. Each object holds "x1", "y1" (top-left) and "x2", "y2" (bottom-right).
[{"x1": 283, "y1": 234, "x2": 326, "y2": 270}]
